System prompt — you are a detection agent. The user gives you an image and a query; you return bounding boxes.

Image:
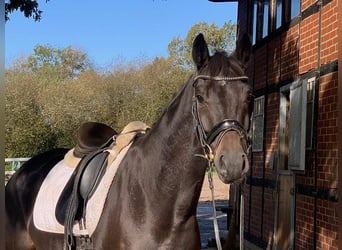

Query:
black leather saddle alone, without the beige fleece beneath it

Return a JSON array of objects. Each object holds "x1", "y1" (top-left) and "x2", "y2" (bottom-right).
[{"x1": 56, "y1": 122, "x2": 117, "y2": 248}]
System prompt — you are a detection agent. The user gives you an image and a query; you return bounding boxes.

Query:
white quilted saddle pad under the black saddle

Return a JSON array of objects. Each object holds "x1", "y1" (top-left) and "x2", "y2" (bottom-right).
[{"x1": 33, "y1": 143, "x2": 132, "y2": 236}]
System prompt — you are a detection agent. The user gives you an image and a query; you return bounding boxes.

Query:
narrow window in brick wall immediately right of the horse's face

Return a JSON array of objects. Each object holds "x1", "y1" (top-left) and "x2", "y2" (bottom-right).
[{"x1": 252, "y1": 96, "x2": 265, "y2": 152}]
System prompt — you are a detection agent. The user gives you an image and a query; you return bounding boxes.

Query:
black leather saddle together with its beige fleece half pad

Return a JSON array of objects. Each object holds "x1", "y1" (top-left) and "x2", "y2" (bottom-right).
[{"x1": 55, "y1": 122, "x2": 148, "y2": 248}]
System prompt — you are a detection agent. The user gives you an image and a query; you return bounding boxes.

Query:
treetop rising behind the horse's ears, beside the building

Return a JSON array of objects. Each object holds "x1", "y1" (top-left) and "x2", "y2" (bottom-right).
[{"x1": 168, "y1": 21, "x2": 236, "y2": 68}]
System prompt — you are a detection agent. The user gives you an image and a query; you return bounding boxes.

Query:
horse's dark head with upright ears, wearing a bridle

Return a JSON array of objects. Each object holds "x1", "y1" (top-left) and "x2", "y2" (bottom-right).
[{"x1": 192, "y1": 34, "x2": 253, "y2": 183}]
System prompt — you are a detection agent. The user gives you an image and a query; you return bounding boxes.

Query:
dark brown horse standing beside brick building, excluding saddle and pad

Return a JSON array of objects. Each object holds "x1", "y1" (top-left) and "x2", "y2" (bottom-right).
[{"x1": 5, "y1": 34, "x2": 252, "y2": 250}]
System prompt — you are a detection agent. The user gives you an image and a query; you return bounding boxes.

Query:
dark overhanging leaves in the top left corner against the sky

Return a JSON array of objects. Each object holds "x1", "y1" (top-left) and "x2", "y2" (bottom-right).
[{"x1": 5, "y1": 0, "x2": 49, "y2": 22}]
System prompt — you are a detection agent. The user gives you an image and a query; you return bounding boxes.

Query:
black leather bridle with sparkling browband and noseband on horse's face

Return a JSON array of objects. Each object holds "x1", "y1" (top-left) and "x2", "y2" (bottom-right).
[{"x1": 192, "y1": 75, "x2": 250, "y2": 160}]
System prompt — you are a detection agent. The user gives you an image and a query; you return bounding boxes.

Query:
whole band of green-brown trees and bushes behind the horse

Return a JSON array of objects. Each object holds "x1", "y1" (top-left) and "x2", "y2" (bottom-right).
[{"x1": 5, "y1": 23, "x2": 235, "y2": 157}]
